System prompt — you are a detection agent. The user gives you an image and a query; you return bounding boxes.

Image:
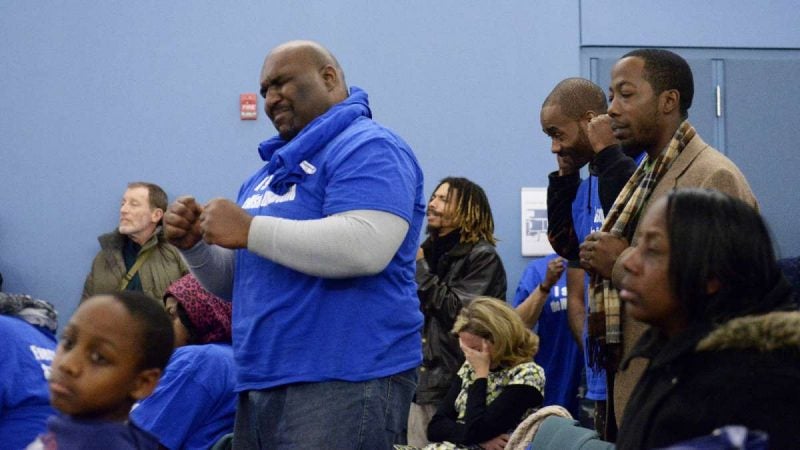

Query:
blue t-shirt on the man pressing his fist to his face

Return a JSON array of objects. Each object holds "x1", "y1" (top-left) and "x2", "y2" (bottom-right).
[{"x1": 572, "y1": 176, "x2": 607, "y2": 400}]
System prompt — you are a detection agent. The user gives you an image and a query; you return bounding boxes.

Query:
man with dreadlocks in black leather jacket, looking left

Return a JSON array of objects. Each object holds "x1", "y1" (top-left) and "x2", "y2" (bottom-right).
[{"x1": 408, "y1": 177, "x2": 506, "y2": 447}]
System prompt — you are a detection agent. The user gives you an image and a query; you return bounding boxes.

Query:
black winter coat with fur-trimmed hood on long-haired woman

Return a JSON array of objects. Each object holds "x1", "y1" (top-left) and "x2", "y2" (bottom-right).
[{"x1": 617, "y1": 311, "x2": 800, "y2": 450}]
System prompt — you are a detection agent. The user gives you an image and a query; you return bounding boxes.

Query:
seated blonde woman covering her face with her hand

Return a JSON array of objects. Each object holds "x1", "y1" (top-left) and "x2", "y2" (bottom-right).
[{"x1": 412, "y1": 297, "x2": 545, "y2": 450}]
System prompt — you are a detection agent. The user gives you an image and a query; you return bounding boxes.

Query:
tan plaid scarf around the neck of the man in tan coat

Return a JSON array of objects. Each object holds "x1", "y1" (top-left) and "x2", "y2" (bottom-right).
[{"x1": 587, "y1": 120, "x2": 695, "y2": 370}]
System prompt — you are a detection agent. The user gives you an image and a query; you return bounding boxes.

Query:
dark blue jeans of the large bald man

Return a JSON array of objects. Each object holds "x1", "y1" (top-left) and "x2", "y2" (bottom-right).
[{"x1": 233, "y1": 369, "x2": 417, "y2": 450}]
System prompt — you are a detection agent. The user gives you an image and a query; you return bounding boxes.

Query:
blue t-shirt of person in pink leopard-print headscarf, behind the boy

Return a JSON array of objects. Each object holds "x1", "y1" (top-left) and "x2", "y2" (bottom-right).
[{"x1": 131, "y1": 344, "x2": 236, "y2": 450}]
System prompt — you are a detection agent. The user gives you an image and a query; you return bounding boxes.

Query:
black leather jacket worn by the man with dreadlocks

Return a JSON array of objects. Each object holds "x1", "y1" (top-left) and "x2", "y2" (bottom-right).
[{"x1": 415, "y1": 239, "x2": 507, "y2": 405}]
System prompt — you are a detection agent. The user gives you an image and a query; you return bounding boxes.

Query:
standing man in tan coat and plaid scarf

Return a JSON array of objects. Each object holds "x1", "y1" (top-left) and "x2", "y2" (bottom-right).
[{"x1": 580, "y1": 49, "x2": 758, "y2": 438}]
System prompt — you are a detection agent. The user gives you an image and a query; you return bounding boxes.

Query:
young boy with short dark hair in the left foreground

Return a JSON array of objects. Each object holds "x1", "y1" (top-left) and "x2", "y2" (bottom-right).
[{"x1": 28, "y1": 291, "x2": 175, "y2": 450}]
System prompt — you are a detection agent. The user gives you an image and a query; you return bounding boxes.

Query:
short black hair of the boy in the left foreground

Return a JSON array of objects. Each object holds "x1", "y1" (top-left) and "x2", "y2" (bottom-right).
[{"x1": 109, "y1": 291, "x2": 175, "y2": 370}]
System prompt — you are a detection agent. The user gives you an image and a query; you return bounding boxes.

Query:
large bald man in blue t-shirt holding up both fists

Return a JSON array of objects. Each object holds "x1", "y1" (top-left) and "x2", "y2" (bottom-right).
[{"x1": 165, "y1": 41, "x2": 425, "y2": 449}]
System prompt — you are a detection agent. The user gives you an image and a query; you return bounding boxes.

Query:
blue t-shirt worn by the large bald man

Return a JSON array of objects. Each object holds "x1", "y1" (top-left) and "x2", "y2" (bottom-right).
[{"x1": 233, "y1": 113, "x2": 425, "y2": 391}]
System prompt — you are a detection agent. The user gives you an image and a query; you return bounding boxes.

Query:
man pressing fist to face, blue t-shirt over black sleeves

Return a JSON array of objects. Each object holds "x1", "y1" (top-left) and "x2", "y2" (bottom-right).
[{"x1": 540, "y1": 78, "x2": 641, "y2": 439}]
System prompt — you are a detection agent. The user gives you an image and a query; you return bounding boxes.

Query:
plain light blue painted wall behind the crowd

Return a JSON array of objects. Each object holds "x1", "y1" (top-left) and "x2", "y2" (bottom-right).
[{"x1": 0, "y1": 0, "x2": 800, "y2": 323}]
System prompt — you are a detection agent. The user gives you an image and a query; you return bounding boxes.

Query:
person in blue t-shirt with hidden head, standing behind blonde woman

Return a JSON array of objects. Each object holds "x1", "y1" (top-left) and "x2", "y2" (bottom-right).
[{"x1": 512, "y1": 254, "x2": 583, "y2": 417}]
